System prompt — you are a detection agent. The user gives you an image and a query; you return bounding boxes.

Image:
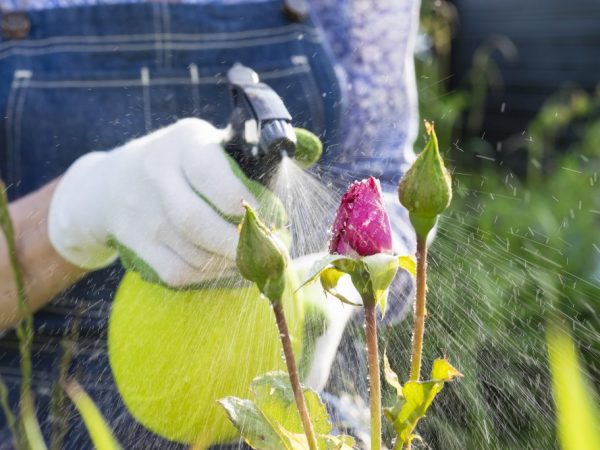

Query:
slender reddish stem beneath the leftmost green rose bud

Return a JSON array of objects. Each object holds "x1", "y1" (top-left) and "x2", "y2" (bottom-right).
[{"x1": 271, "y1": 301, "x2": 318, "y2": 450}]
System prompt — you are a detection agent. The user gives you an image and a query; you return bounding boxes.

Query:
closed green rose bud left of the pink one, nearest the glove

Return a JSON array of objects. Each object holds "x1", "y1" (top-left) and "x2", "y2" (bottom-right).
[{"x1": 236, "y1": 203, "x2": 288, "y2": 301}]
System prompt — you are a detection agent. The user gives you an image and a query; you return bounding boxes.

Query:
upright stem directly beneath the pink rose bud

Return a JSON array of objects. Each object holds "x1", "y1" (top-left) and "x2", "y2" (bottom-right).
[{"x1": 365, "y1": 302, "x2": 381, "y2": 450}]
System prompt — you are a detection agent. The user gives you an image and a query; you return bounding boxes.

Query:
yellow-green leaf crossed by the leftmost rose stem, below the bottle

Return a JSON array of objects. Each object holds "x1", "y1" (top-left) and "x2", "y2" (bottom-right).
[{"x1": 250, "y1": 371, "x2": 331, "y2": 434}]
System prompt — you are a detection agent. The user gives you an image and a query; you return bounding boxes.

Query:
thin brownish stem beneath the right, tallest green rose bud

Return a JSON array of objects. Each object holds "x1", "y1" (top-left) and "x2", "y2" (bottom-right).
[{"x1": 410, "y1": 236, "x2": 427, "y2": 381}]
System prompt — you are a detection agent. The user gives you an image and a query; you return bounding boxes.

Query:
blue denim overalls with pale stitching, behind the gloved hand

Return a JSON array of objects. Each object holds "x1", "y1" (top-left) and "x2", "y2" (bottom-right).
[{"x1": 0, "y1": 0, "x2": 341, "y2": 449}]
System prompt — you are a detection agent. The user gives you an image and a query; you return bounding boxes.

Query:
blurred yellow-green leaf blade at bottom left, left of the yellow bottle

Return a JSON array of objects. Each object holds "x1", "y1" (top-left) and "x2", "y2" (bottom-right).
[{"x1": 65, "y1": 381, "x2": 121, "y2": 450}]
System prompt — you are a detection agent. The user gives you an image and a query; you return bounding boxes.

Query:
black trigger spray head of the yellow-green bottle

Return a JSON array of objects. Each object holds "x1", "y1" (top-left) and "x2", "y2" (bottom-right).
[{"x1": 225, "y1": 64, "x2": 296, "y2": 181}]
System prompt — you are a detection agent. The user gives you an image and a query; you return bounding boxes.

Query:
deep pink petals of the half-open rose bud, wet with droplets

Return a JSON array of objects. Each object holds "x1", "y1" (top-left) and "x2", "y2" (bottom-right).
[{"x1": 329, "y1": 177, "x2": 392, "y2": 256}]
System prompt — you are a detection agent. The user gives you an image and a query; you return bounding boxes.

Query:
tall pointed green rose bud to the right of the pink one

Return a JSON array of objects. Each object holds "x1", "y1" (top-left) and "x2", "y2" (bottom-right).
[{"x1": 398, "y1": 122, "x2": 452, "y2": 238}]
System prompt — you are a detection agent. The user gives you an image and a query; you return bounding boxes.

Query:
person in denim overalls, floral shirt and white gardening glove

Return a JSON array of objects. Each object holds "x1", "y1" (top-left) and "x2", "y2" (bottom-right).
[{"x1": 0, "y1": 0, "x2": 419, "y2": 448}]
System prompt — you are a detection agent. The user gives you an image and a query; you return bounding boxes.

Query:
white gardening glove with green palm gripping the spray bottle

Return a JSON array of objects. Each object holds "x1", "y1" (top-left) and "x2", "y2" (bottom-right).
[{"x1": 48, "y1": 119, "x2": 284, "y2": 287}]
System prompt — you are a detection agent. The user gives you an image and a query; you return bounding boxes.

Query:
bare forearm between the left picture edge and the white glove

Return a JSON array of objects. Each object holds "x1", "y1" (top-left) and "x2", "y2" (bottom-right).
[{"x1": 0, "y1": 180, "x2": 85, "y2": 329}]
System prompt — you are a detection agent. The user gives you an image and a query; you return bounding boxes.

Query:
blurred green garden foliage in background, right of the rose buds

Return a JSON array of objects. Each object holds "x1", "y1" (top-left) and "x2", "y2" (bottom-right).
[{"x1": 387, "y1": 0, "x2": 600, "y2": 450}]
